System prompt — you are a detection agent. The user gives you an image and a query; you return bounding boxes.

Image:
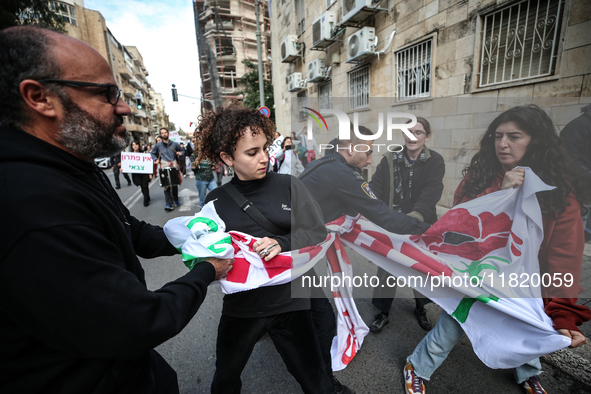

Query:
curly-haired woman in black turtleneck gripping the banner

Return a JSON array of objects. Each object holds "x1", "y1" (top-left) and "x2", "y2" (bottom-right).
[{"x1": 198, "y1": 105, "x2": 351, "y2": 393}]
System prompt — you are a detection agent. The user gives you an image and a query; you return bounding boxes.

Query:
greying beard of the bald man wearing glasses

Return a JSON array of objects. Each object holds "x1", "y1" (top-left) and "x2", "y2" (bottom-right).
[{"x1": 56, "y1": 94, "x2": 131, "y2": 159}]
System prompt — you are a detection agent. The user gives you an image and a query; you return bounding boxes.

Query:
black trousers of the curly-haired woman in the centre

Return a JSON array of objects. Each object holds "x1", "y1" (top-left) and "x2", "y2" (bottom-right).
[{"x1": 211, "y1": 311, "x2": 334, "y2": 394}]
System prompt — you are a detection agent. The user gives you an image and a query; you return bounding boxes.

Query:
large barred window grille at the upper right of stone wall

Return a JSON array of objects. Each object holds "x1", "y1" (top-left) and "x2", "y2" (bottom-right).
[{"x1": 480, "y1": 0, "x2": 563, "y2": 87}]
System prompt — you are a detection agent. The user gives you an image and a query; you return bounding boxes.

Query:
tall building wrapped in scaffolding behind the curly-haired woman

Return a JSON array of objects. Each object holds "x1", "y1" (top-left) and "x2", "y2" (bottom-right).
[{"x1": 193, "y1": 0, "x2": 271, "y2": 110}]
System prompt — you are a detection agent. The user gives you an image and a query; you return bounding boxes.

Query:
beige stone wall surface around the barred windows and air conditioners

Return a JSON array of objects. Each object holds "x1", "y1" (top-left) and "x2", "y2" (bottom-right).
[{"x1": 271, "y1": 0, "x2": 591, "y2": 207}]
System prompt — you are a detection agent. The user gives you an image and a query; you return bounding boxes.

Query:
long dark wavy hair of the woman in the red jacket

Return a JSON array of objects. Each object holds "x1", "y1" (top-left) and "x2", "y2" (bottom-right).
[{"x1": 460, "y1": 104, "x2": 590, "y2": 216}]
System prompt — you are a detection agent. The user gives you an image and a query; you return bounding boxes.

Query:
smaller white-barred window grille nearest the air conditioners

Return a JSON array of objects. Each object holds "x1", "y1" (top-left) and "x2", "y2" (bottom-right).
[{"x1": 396, "y1": 40, "x2": 432, "y2": 100}]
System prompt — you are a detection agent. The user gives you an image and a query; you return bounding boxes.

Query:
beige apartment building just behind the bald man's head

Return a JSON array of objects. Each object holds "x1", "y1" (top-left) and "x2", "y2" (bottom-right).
[{"x1": 49, "y1": 0, "x2": 162, "y2": 144}]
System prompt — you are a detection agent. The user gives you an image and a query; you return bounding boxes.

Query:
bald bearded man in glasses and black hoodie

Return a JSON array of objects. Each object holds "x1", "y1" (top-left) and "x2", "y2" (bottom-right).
[{"x1": 0, "y1": 26, "x2": 232, "y2": 394}]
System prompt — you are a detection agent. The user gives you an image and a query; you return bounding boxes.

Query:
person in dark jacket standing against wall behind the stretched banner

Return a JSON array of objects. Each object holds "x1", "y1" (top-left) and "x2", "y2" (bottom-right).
[{"x1": 369, "y1": 117, "x2": 445, "y2": 333}]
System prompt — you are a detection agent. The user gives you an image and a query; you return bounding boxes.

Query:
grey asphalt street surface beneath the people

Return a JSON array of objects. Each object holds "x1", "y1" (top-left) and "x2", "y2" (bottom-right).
[{"x1": 105, "y1": 170, "x2": 588, "y2": 394}]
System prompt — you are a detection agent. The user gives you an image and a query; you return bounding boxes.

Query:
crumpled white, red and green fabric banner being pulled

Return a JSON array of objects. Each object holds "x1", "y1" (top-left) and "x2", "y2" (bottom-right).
[{"x1": 164, "y1": 168, "x2": 570, "y2": 370}]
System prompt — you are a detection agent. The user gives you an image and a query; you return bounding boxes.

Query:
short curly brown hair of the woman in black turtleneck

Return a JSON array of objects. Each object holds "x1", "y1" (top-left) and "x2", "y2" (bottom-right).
[{"x1": 196, "y1": 102, "x2": 276, "y2": 163}]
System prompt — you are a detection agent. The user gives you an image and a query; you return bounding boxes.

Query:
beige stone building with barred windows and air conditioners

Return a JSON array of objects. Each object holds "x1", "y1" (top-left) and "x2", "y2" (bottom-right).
[{"x1": 271, "y1": 0, "x2": 591, "y2": 207}]
